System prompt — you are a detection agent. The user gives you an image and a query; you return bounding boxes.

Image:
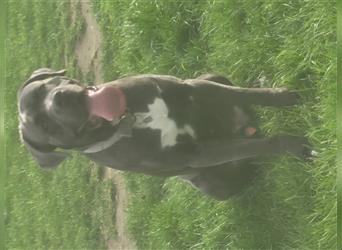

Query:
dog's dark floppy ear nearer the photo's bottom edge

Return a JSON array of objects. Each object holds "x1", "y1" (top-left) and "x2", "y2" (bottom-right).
[{"x1": 22, "y1": 137, "x2": 69, "y2": 169}]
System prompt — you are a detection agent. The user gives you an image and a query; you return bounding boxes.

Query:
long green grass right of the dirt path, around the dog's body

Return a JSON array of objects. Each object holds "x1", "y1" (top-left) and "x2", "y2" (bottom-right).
[{"x1": 93, "y1": 0, "x2": 336, "y2": 249}]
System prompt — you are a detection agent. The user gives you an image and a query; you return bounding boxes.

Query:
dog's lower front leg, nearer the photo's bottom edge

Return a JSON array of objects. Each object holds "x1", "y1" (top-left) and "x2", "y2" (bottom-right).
[{"x1": 188, "y1": 136, "x2": 308, "y2": 168}]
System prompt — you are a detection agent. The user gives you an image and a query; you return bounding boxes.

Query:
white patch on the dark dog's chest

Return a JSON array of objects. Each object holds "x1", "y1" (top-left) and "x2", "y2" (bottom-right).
[{"x1": 133, "y1": 98, "x2": 195, "y2": 148}]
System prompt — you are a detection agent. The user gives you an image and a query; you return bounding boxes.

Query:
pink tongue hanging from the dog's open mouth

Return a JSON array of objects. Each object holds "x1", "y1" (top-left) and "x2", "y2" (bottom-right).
[{"x1": 87, "y1": 86, "x2": 126, "y2": 121}]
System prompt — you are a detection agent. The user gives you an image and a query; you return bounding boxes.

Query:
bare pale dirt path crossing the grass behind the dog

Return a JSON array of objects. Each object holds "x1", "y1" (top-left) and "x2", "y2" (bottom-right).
[{"x1": 72, "y1": 0, "x2": 136, "y2": 250}]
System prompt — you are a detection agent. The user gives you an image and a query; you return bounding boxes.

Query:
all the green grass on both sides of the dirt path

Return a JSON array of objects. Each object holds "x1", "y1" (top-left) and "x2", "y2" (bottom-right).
[{"x1": 5, "y1": 0, "x2": 336, "y2": 250}]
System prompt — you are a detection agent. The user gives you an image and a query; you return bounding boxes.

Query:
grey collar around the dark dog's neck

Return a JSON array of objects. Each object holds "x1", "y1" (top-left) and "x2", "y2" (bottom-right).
[{"x1": 81, "y1": 111, "x2": 135, "y2": 154}]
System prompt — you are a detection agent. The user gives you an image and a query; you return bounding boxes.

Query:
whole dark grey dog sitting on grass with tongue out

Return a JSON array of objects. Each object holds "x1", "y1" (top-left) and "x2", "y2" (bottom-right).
[{"x1": 18, "y1": 68, "x2": 308, "y2": 200}]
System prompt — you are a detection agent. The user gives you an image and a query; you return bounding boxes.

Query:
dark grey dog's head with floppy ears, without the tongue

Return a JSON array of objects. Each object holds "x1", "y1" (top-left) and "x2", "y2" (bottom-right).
[{"x1": 18, "y1": 68, "x2": 113, "y2": 168}]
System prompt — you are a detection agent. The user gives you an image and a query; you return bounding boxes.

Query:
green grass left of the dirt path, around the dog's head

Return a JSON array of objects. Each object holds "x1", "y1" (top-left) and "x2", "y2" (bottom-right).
[{"x1": 5, "y1": 0, "x2": 115, "y2": 249}]
